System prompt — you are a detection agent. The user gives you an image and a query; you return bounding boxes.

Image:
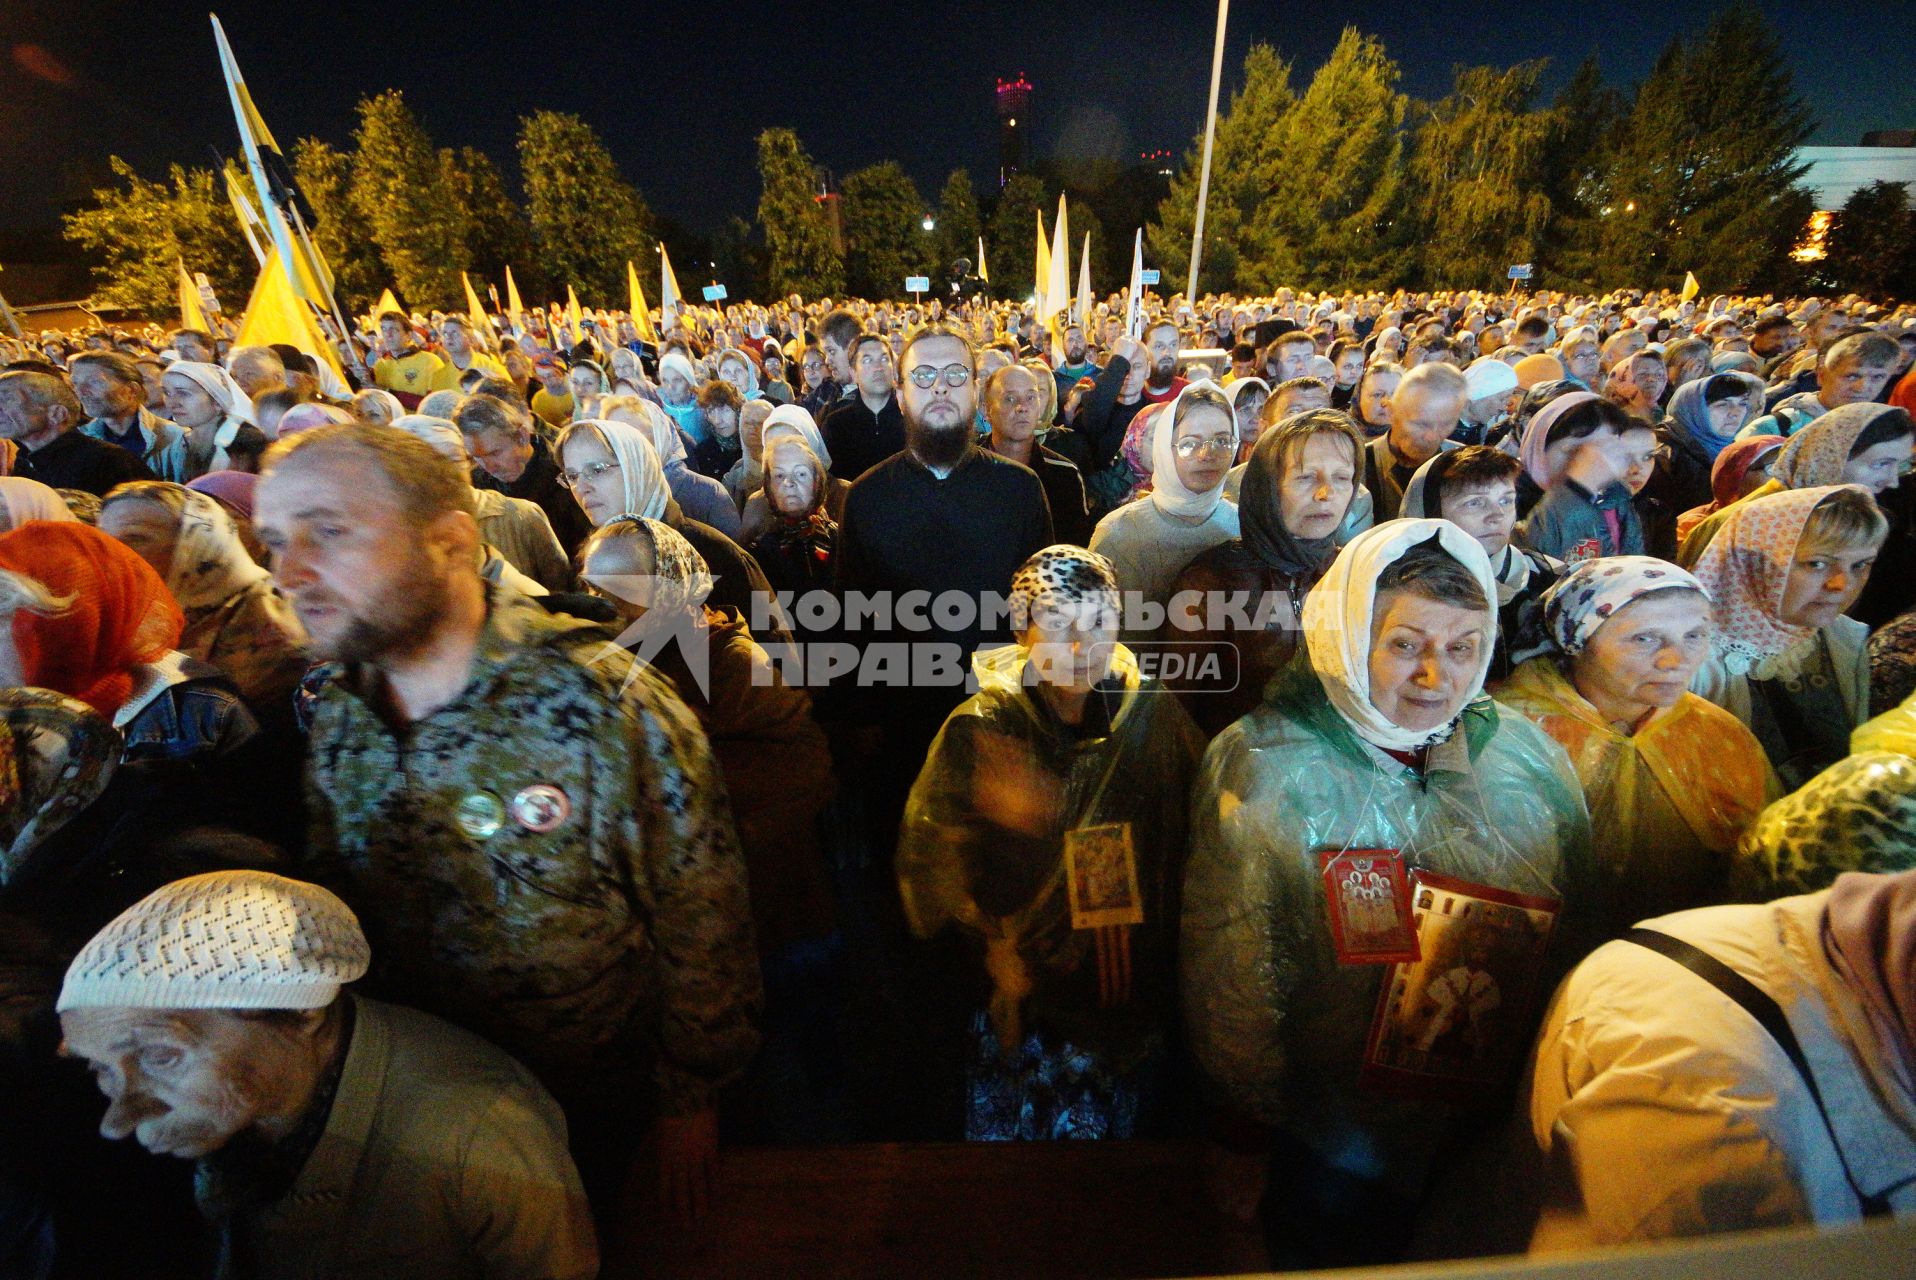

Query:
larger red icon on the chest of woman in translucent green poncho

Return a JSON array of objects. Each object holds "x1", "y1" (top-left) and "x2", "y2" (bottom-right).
[{"x1": 1360, "y1": 872, "x2": 1562, "y2": 1102}]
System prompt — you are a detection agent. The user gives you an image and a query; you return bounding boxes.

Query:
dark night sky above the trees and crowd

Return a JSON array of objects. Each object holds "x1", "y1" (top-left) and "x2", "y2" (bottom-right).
[{"x1": 0, "y1": 0, "x2": 1916, "y2": 243}]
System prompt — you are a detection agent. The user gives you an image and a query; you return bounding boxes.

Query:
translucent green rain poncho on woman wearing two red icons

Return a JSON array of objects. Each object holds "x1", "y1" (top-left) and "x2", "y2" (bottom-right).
[{"x1": 1180, "y1": 655, "x2": 1600, "y2": 1196}]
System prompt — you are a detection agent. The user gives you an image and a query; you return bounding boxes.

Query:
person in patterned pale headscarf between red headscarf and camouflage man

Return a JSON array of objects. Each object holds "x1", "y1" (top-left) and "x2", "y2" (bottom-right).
[{"x1": 100, "y1": 481, "x2": 307, "y2": 717}]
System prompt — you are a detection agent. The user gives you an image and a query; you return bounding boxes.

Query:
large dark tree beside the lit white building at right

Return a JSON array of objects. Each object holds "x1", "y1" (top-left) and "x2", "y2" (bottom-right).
[{"x1": 1583, "y1": 4, "x2": 1811, "y2": 291}]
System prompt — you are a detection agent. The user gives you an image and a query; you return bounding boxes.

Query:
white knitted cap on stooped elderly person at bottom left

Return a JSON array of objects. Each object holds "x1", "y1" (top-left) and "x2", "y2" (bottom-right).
[{"x1": 56, "y1": 872, "x2": 372, "y2": 1012}]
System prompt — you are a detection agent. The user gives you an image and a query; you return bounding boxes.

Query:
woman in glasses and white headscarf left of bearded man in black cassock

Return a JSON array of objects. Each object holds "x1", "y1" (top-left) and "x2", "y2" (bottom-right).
[{"x1": 554, "y1": 418, "x2": 791, "y2": 642}]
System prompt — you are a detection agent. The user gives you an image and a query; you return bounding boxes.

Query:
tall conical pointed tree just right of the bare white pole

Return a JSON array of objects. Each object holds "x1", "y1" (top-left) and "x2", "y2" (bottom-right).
[{"x1": 1249, "y1": 27, "x2": 1414, "y2": 293}]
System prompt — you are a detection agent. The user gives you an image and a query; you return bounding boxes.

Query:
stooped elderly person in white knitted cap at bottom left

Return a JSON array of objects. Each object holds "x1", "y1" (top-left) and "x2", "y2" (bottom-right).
[{"x1": 57, "y1": 872, "x2": 598, "y2": 1280}]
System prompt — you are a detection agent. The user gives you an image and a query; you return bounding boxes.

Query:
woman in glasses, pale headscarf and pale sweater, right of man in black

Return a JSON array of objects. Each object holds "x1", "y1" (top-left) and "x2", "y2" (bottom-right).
[{"x1": 1090, "y1": 381, "x2": 1238, "y2": 642}]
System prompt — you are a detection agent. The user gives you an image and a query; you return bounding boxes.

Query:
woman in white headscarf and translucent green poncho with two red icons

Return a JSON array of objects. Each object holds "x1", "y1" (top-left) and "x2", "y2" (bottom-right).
[{"x1": 1180, "y1": 519, "x2": 1596, "y2": 1267}]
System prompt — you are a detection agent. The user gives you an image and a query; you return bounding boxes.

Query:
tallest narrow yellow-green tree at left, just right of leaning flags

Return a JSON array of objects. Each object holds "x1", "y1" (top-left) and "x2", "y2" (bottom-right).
[{"x1": 353, "y1": 88, "x2": 466, "y2": 309}]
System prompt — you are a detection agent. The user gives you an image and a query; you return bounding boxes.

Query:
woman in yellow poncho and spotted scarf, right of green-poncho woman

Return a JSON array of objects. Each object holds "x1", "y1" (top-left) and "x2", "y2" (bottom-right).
[{"x1": 1496, "y1": 556, "x2": 1778, "y2": 933}]
